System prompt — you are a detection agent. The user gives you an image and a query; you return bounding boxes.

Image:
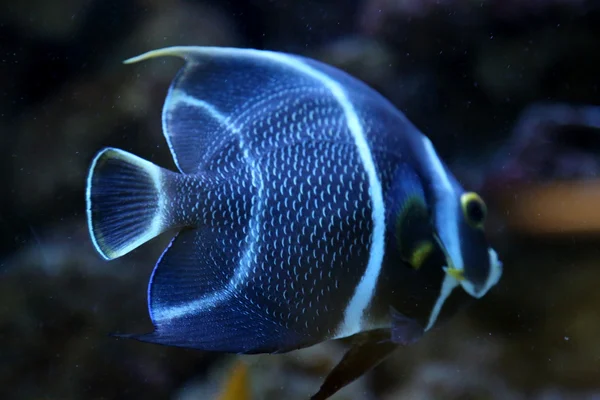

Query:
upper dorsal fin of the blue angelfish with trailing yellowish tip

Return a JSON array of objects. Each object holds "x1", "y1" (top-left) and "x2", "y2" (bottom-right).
[{"x1": 125, "y1": 47, "x2": 363, "y2": 173}]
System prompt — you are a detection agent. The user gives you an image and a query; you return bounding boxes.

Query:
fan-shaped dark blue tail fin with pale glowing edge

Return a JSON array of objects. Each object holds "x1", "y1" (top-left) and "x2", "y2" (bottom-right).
[{"x1": 86, "y1": 148, "x2": 175, "y2": 260}]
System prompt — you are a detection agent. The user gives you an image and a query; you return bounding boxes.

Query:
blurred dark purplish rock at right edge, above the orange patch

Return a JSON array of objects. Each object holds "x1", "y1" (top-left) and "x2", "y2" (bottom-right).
[{"x1": 486, "y1": 104, "x2": 600, "y2": 188}]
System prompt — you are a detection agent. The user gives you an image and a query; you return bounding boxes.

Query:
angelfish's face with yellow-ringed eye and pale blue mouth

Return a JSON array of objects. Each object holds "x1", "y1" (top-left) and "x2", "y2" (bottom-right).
[{"x1": 432, "y1": 189, "x2": 502, "y2": 298}]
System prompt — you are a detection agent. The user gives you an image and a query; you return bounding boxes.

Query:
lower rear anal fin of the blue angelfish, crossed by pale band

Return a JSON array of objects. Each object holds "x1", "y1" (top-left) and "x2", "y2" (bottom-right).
[{"x1": 126, "y1": 226, "x2": 312, "y2": 354}]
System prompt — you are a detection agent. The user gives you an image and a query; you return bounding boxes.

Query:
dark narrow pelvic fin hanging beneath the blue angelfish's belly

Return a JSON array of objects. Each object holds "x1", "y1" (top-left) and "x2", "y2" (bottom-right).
[{"x1": 310, "y1": 331, "x2": 399, "y2": 400}]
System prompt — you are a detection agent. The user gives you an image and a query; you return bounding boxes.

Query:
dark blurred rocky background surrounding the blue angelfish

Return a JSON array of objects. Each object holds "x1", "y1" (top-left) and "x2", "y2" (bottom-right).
[{"x1": 0, "y1": 0, "x2": 600, "y2": 400}]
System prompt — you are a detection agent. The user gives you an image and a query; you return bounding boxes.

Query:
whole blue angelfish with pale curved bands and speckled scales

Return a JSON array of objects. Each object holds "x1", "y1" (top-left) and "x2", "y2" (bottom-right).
[{"x1": 86, "y1": 47, "x2": 502, "y2": 399}]
